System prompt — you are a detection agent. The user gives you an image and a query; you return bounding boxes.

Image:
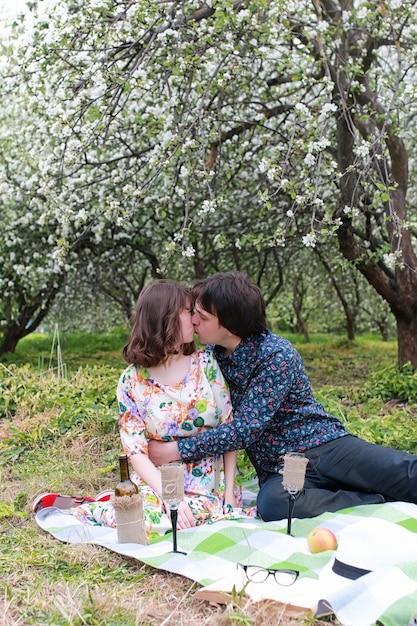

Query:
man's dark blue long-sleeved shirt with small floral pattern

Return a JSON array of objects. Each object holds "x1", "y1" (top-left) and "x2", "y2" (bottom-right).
[{"x1": 178, "y1": 330, "x2": 348, "y2": 484}]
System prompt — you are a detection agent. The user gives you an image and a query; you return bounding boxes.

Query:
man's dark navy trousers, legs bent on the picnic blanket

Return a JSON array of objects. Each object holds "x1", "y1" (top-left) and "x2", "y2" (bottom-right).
[{"x1": 257, "y1": 435, "x2": 417, "y2": 521}]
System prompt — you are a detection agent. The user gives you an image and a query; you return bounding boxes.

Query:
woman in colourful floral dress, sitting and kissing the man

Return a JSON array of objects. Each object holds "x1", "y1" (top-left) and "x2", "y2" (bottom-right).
[{"x1": 67, "y1": 280, "x2": 240, "y2": 532}]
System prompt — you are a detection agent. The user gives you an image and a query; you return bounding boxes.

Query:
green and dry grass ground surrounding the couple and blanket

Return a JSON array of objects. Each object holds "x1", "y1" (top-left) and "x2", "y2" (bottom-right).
[{"x1": 0, "y1": 329, "x2": 417, "y2": 626}]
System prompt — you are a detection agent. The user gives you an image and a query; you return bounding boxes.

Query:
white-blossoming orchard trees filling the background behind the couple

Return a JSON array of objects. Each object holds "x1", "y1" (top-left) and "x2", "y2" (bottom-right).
[{"x1": 0, "y1": 0, "x2": 417, "y2": 367}]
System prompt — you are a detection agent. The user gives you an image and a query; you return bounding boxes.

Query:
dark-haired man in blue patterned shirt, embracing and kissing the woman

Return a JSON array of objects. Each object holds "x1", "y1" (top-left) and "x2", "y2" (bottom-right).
[{"x1": 150, "y1": 272, "x2": 417, "y2": 521}]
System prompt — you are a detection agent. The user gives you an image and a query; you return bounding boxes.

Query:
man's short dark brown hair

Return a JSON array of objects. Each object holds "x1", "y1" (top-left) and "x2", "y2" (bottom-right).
[{"x1": 193, "y1": 272, "x2": 266, "y2": 339}]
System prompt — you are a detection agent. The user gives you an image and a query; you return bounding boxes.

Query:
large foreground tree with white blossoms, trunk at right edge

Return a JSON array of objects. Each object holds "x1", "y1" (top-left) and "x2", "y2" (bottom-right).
[{"x1": 0, "y1": 0, "x2": 417, "y2": 366}]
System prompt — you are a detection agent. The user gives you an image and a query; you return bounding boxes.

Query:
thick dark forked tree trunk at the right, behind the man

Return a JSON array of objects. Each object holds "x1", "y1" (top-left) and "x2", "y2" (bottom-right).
[{"x1": 337, "y1": 71, "x2": 417, "y2": 368}]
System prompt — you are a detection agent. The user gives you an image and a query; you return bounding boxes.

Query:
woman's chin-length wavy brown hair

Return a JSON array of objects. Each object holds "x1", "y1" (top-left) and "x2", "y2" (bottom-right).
[{"x1": 123, "y1": 280, "x2": 195, "y2": 367}]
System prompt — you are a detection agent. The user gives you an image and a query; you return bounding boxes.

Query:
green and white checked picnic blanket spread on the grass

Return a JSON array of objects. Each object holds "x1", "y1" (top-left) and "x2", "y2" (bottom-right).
[{"x1": 36, "y1": 502, "x2": 417, "y2": 626}]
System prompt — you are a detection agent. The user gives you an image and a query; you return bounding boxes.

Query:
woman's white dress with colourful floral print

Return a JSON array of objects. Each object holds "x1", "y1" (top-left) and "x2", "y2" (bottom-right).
[{"x1": 71, "y1": 350, "x2": 241, "y2": 534}]
